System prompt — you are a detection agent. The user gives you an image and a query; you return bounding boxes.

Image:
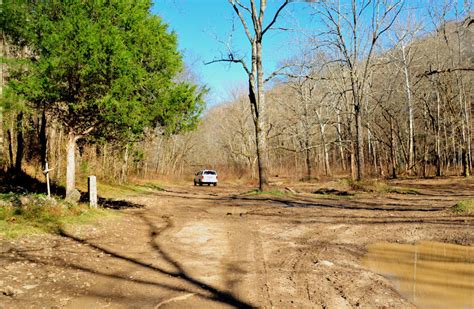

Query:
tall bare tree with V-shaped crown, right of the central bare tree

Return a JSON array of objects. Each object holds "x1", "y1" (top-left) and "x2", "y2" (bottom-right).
[{"x1": 314, "y1": 0, "x2": 403, "y2": 180}]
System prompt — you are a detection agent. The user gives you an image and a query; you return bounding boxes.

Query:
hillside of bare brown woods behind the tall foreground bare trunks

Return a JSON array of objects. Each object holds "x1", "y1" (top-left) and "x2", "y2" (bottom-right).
[{"x1": 154, "y1": 11, "x2": 474, "y2": 179}]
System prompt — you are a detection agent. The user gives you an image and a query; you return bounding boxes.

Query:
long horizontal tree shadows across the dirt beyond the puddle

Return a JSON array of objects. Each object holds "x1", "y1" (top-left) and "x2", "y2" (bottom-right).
[{"x1": 146, "y1": 192, "x2": 473, "y2": 226}]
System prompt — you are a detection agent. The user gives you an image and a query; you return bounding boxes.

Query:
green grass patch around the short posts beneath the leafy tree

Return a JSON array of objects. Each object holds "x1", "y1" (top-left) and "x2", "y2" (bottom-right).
[{"x1": 0, "y1": 194, "x2": 115, "y2": 238}]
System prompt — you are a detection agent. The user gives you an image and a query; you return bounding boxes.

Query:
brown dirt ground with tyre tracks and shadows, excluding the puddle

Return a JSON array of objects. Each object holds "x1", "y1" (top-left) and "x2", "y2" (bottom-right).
[{"x1": 0, "y1": 179, "x2": 474, "y2": 308}]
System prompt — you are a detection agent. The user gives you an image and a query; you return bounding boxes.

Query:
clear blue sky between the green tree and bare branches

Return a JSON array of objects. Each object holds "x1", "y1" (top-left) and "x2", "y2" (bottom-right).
[{"x1": 152, "y1": 0, "x2": 470, "y2": 106}]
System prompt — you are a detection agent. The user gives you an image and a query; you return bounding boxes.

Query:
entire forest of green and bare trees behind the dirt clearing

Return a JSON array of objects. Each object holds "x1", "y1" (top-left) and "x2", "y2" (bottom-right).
[{"x1": 0, "y1": 1, "x2": 474, "y2": 190}]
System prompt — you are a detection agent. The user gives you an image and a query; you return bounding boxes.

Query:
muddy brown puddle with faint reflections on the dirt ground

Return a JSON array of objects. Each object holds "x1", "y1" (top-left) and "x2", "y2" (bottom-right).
[{"x1": 364, "y1": 241, "x2": 474, "y2": 308}]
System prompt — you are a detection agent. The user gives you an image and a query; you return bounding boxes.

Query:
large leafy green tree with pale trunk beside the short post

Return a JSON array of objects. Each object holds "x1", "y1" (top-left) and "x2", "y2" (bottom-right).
[{"x1": 2, "y1": 0, "x2": 205, "y2": 196}]
